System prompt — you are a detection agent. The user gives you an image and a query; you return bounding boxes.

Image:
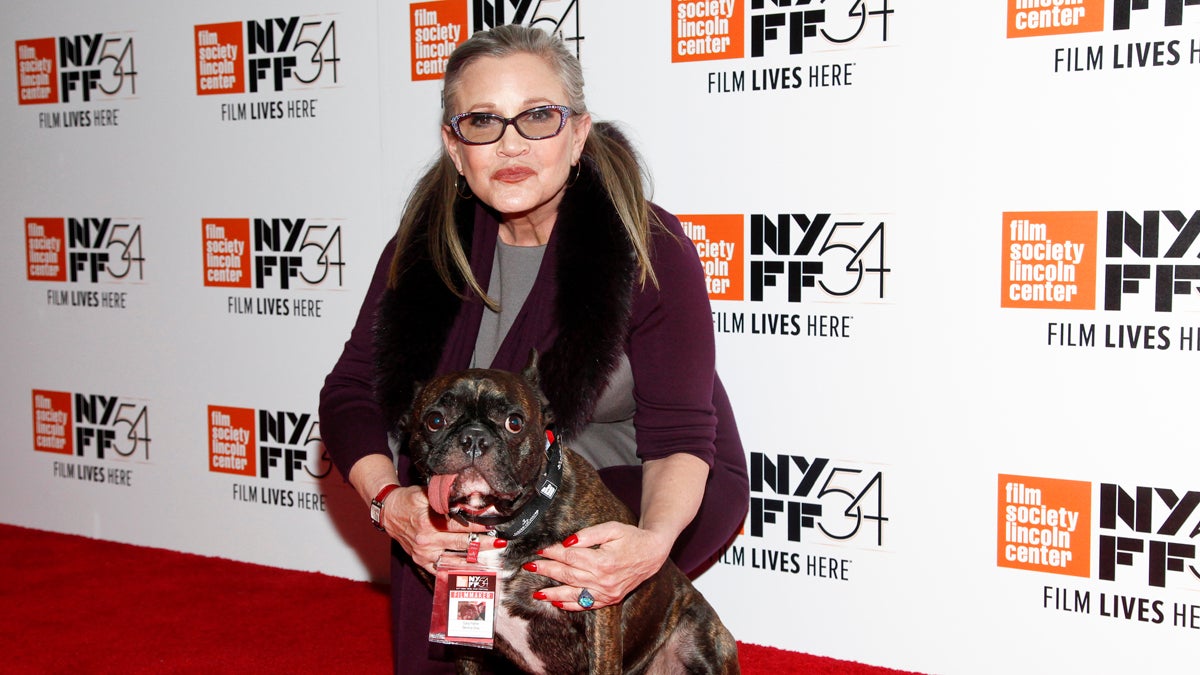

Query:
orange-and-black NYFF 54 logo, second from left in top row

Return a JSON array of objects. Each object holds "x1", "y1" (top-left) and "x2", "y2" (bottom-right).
[{"x1": 194, "y1": 17, "x2": 341, "y2": 96}]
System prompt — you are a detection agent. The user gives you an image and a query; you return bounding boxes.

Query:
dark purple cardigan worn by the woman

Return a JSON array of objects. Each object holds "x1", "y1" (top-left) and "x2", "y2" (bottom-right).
[{"x1": 319, "y1": 204, "x2": 749, "y2": 571}]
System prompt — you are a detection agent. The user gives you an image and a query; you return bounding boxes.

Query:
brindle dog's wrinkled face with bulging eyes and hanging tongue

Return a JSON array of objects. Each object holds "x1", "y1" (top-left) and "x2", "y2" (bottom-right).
[{"x1": 406, "y1": 369, "x2": 548, "y2": 525}]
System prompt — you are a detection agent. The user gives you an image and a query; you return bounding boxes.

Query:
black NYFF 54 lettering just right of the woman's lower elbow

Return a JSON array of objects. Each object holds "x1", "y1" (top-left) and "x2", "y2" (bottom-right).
[{"x1": 746, "y1": 453, "x2": 888, "y2": 546}]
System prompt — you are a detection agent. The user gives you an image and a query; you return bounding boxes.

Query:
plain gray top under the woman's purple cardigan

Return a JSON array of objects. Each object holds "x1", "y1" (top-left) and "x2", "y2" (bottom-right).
[{"x1": 472, "y1": 240, "x2": 641, "y2": 468}]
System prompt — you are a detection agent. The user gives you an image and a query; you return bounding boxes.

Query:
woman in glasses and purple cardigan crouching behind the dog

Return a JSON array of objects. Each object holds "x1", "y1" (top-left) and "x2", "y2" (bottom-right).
[{"x1": 320, "y1": 25, "x2": 749, "y2": 673}]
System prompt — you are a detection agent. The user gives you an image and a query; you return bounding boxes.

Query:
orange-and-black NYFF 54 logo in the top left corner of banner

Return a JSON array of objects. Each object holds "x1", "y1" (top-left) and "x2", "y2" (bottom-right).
[{"x1": 17, "y1": 32, "x2": 138, "y2": 106}]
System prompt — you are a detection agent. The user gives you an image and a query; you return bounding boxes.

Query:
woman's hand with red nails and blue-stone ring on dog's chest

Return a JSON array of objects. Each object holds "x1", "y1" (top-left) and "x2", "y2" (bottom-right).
[{"x1": 524, "y1": 522, "x2": 674, "y2": 611}]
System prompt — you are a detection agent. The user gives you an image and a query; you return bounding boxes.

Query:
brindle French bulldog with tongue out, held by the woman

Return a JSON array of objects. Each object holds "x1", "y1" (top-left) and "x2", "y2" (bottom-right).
[{"x1": 404, "y1": 354, "x2": 739, "y2": 675}]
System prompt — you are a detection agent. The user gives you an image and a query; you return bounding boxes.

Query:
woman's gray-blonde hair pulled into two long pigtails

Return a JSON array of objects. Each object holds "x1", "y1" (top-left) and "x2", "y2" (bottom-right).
[{"x1": 389, "y1": 24, "x2": 661, "y2": 302}]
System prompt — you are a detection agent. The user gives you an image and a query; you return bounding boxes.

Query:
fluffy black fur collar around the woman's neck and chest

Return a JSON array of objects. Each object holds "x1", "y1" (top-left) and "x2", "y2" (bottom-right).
[{"x1": 376, "y1": 161, "x2": 637, "y2": 438}]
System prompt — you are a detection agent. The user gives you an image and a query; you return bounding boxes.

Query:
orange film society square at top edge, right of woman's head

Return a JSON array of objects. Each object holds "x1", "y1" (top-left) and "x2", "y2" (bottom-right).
[{"x1": 671, "y1": 0, "x2": 745, "y2": 64}]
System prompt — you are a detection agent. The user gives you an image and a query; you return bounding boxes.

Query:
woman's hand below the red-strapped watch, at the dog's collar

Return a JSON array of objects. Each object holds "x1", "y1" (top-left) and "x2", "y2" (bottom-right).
[{"x1": 380, "y1": 485, "x2": 505, "y2": 574}]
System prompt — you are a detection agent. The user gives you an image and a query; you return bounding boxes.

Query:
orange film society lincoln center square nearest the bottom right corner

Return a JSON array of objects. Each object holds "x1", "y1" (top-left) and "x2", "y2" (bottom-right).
[{"x1": 996, "y1": 473, "x2": 1092, "y2": 577}]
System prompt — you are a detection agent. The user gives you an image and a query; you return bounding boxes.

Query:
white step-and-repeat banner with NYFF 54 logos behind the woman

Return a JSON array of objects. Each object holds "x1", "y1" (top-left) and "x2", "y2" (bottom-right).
[{"x1": 0, "y1": 0, "x2": 1200, "y2": 673}]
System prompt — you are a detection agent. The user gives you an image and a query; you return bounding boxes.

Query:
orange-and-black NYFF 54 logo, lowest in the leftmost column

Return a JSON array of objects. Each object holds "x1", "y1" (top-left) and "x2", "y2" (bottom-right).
[{"x1": 32, "y1": 389, "x2": 150, "y2": 461}]
